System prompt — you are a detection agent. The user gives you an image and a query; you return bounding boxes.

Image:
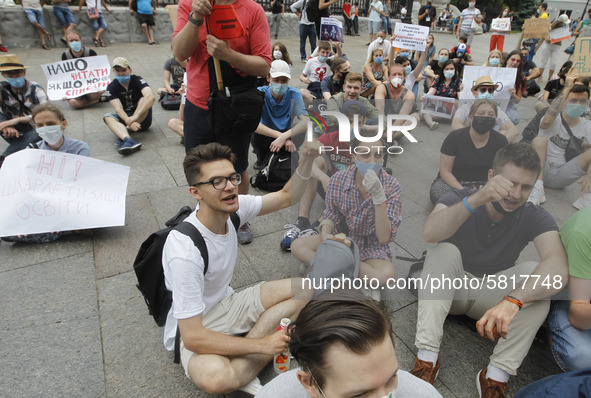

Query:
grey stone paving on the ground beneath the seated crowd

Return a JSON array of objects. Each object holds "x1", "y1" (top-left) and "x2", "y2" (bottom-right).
[{"x1": 0, "y1": 28, "x2": 579, "y2": 398}]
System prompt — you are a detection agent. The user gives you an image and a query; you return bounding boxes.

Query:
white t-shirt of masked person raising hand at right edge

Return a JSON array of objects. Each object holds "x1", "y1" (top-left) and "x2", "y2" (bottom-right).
[{"x1": 538, "y1": 113, "x2": 591, "y2": 166}]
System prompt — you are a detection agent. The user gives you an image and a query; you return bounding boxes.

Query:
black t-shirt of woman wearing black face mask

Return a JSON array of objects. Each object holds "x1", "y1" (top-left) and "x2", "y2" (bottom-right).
[{"x1": 441, "y1": 127, "x2": 509, "y2": 181}]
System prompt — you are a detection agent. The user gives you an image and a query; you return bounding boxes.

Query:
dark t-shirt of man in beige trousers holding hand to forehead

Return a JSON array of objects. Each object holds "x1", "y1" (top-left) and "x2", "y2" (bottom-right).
[{"x1": 437, "y1": 189, "x2": 558, "y2": 277}]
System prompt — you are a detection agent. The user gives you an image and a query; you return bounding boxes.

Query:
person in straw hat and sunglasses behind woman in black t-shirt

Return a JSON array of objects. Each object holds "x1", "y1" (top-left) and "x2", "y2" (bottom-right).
[{"x1": 451, "y1": 76, "x2": 519, "y2": 142}]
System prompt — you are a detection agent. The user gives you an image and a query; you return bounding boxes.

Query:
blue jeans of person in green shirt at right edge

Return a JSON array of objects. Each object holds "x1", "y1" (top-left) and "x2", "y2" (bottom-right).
[{"x1": 548, "y1": 300, "x2": 591, "y2": 372}]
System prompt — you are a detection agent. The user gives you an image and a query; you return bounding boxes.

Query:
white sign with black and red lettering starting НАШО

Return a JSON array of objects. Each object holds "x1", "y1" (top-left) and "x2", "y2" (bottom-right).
[{"x1": 41, "y1": 55, "x2": 111, "y2": 101}]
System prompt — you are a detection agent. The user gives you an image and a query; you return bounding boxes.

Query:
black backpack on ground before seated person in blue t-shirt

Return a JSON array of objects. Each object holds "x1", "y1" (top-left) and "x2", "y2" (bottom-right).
[{"x1": 250, "y1": 149, "x2": 298, "y2": 192}]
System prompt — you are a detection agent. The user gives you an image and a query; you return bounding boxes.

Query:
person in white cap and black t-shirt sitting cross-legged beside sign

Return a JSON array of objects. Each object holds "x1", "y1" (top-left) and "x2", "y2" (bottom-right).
[{"x1": 103, "y1": 57, "x2": 156, "y2": 155}]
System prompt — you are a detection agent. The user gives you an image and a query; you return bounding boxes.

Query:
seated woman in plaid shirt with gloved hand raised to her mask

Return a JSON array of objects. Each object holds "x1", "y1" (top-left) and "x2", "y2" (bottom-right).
[{"x1": 291, "y1": 137, "x2": 402, "y2": 298}]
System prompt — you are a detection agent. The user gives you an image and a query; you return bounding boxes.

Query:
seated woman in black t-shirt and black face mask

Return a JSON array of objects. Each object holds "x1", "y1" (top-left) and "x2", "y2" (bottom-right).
[{"x1": 429, "y1": 99, "x2": 509, "y2": 204}]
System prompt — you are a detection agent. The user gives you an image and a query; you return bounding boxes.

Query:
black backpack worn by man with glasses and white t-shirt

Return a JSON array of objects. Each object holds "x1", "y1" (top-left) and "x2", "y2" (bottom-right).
[{"x1": 133, "y1": 206, "x2": 240, "y2": 363}]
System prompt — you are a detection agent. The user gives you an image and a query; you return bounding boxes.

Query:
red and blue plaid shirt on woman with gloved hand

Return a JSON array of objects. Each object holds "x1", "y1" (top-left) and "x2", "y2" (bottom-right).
[{"x1": 322, "y1": 167, "x2": 402, "y2": 261}]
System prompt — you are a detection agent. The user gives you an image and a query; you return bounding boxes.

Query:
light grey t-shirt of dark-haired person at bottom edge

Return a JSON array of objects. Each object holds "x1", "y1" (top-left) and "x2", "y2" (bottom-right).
[{"x1": 255, "y1": 369, "x2": 441, "y2": 398}]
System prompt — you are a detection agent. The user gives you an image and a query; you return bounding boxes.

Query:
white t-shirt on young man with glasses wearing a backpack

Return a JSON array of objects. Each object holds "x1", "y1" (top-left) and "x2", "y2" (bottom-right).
[{"x1": 162, "y1": 195, "x2": 263, "y2": 351}]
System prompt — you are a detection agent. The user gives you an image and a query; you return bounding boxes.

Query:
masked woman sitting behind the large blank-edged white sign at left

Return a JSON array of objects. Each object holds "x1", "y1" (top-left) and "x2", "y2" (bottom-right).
[{"x1": 2, "y1": 102, "x2": 90, "y2": 243}]
